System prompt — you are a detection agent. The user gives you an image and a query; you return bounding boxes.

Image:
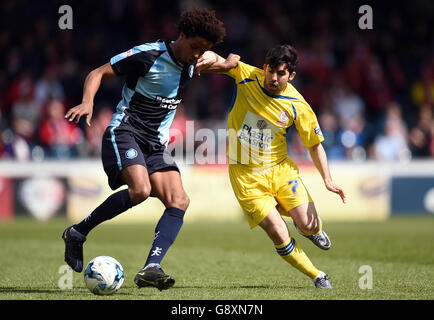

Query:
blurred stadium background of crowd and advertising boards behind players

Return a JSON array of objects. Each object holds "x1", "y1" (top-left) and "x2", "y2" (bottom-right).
[{"x1": 0, "y1": 0, "x2": 434, "y2": 222}]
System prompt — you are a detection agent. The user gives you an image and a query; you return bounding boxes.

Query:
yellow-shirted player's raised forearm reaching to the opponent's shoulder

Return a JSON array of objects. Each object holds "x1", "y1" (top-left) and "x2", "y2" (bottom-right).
[{"x1": 195, "y1": 51, "x2": 240, "y2": 75}]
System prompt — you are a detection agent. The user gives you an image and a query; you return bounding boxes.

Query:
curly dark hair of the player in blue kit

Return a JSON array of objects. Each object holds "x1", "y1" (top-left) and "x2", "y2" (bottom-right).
[{"x1": 178, "y1": 8, "x2": 226, "y2": 44}]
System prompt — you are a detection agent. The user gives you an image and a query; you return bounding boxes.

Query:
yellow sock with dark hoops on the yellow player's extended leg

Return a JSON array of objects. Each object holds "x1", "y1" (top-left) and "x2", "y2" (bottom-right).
[{"x1": 275, "y1": 237, "x2": 320, "y2": 279}]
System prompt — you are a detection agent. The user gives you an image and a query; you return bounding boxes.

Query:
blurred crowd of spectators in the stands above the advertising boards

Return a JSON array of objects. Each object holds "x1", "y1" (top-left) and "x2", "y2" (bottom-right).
[{"x1": 0, "y1": 0, "x2": 434, "y2": 161}]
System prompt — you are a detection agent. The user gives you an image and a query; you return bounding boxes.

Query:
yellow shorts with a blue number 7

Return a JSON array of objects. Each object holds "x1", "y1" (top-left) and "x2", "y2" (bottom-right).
[{"x1": 229, "y1": 158, "x2": 312, "y2": 228}]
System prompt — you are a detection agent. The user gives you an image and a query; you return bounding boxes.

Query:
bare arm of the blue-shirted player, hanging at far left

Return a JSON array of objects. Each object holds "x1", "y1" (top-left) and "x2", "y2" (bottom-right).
[{"x1": 65, "y1": 62, "x2": 116, "y2": 127}]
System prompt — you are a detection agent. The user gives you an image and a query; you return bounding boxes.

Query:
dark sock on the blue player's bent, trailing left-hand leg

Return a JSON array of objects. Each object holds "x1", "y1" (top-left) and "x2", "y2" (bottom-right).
[{"x1": 74, "y1": 189, "x2": 134, "y2": 236}]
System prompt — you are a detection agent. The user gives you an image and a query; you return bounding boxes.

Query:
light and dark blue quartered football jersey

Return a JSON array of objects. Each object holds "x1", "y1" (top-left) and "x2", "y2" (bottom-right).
[{"x1": 110, "y1": 41, "x2": 194, "y2": 146}]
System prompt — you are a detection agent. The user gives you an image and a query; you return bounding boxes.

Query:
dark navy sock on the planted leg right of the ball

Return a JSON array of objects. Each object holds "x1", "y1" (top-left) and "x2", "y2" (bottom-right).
[{"x1": 145, "y1": 207, "x2": 185, "y2": 266}]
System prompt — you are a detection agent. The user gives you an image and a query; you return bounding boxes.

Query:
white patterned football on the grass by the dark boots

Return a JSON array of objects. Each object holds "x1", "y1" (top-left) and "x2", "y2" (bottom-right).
[{"x1": 84, "y1": 256, "x2": 124, "y2": 295}]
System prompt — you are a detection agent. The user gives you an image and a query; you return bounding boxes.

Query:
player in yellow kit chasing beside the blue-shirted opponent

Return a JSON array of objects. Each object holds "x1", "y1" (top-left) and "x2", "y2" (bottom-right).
[{"x1": 196, "y1": 45, "x2": 346, "y2": 288}]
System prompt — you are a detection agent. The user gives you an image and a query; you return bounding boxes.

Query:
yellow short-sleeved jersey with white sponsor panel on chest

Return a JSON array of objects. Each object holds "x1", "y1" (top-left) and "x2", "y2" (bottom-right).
[{"x1": 222, "y1": 61, "x2": 324, "y2": 167}]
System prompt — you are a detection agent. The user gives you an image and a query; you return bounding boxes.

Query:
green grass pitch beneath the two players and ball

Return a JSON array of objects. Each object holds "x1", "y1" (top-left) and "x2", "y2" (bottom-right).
[{"x1": 0, "y1": 217, "x2": 434, "y2": 300}]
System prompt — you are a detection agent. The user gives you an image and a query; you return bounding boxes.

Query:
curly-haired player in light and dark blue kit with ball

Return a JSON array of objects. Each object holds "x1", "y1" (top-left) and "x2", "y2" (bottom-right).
[{"x1": 62, "y1": 8, "x2": 226, "y2": 290}]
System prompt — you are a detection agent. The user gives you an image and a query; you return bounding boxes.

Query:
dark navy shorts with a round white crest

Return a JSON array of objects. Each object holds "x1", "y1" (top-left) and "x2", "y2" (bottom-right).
[{"x1": 101, "y1": 126, "x2": 179, "y2": 190}]
